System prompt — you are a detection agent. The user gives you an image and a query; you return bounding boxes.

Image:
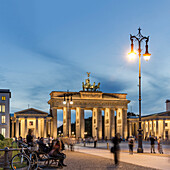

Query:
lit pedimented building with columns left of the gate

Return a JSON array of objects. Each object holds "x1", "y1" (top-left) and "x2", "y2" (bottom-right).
[{"x1": 11, "y1": 108, "x2": 52, "y2": 138}]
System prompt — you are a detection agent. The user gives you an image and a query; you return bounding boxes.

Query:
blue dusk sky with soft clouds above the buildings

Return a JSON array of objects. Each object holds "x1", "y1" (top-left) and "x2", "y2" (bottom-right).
[{"x1": 0, "y1": 0, "x2": 170, "y2": 125}]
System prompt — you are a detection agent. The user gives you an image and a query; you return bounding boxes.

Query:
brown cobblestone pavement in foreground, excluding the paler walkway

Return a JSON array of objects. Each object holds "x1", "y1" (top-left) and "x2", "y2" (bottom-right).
[{"x1": 39, "y1": 151, "x2": 157, "y2": 170}]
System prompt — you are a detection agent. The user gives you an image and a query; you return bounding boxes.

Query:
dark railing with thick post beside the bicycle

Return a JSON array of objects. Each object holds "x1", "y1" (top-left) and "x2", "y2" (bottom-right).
[{"x1": 0, "y1": 147, "x2": 21, "y2": 170}]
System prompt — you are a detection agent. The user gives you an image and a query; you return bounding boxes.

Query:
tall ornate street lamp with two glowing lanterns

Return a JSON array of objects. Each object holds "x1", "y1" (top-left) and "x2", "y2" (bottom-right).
[{"x1": 129, "y1": 28, "x2": 151, "y2": 153}]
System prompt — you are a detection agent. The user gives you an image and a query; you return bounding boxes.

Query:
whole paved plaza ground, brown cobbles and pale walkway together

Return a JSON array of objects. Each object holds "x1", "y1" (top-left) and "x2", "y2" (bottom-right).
[{"x1": 39, "y1": 143, "x2": 170, "y2": 170}]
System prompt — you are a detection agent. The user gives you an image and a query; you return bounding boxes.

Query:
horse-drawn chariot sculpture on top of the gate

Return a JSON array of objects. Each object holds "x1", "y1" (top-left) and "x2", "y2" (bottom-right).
[{"x1": 82, "y1": 72, "x2": 100, "y2": 91}]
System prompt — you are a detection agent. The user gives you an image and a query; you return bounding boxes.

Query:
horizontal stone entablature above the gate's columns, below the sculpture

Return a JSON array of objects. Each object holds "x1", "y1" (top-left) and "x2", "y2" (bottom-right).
[{"x1": 48, "y1": 91, "x2": 130, "y2": 109}]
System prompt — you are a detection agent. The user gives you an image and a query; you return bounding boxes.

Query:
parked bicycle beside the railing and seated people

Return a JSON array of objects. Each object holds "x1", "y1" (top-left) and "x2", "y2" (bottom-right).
[{"x1": 11, "y1": 143, "x2": 38, "y2": 170}]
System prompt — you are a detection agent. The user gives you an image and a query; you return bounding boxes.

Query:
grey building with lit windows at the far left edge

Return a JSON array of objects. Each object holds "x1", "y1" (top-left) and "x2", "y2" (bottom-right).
[{"x1": 0, "y1": 89, "x2": 11, "y2": 138}]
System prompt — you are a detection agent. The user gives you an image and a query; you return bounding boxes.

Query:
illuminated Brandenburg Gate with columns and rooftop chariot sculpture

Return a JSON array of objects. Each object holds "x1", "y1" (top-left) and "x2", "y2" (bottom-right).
[{"x1": 48, "y1": 73, "x2": 130, "y2": 139}]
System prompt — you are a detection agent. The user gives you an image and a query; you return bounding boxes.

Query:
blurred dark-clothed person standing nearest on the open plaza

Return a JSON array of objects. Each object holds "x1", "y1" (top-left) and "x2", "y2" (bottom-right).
[{"x1": 112, "y1": 133, "x2": 121, "y2": 166}]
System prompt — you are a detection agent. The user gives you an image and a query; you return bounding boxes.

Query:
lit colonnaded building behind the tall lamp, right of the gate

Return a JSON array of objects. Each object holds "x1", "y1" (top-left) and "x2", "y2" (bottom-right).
[{"x1": 128, "y1": 100, "x2": 170, "y2": 139}]
